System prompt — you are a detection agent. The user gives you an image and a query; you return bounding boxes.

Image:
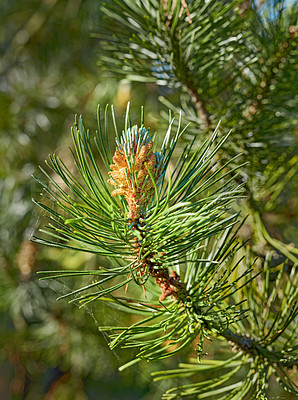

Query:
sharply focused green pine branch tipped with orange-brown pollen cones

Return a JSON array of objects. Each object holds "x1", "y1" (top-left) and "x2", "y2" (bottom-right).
[{"x1": 35, "y1": 103, "x2": 297, "y2": 399}]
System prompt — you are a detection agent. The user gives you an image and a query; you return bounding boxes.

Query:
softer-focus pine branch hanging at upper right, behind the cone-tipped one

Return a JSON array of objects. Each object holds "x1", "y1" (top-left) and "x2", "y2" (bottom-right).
[{"x1": 97, "y1": 0, "x2": 298, "y2": 262}]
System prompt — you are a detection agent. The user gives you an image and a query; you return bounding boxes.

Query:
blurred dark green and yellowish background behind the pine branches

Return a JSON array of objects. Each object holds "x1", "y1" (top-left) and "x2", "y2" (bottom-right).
[{"x1": 0, "y1": 0, "x2": 291, "y2": 400}]
